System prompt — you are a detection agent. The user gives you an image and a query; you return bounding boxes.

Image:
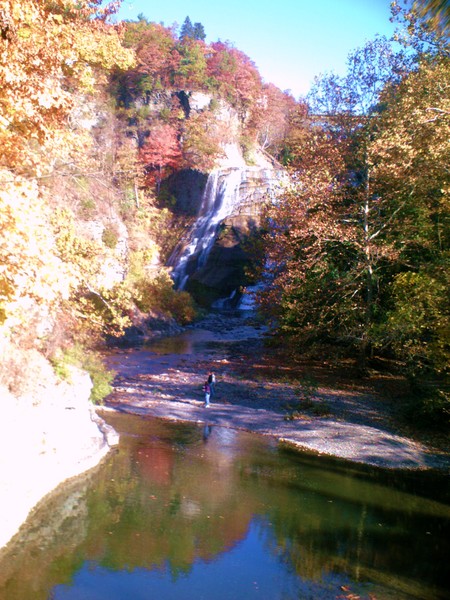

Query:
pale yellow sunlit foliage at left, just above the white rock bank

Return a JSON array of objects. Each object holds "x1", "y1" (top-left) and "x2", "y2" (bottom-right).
[{"x1": 0, "y1": 180, "x2": 130, "y2": 340}]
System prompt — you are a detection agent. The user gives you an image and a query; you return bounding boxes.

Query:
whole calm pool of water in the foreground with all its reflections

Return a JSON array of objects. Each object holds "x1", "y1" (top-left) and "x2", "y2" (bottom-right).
[{"x1": 0, "y1": 413, "x2": 450, "y2": 600}]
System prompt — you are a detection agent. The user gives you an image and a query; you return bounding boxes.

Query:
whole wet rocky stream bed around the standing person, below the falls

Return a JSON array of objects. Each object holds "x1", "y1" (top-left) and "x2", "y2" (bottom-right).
[{"x1": 106, "y1": 313, "x2": 450, "y2": 469}]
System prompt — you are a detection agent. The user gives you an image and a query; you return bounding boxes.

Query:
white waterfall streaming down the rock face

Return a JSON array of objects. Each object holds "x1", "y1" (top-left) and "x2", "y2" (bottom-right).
[{"x1": 168, "y1": 167, "x2": 279, "y2": 290}]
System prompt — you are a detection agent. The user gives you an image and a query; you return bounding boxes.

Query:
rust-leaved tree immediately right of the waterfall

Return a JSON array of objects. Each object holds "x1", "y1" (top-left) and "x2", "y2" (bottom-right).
[{"x1": 260, "y1": 128, "x2": 365, "y2": 353}]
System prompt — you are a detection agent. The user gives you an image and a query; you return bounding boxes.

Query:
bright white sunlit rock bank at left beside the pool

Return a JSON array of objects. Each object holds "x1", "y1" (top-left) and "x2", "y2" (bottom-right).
[{"x1": 0, "y1": 365, "x2": 118, "y2": 547}]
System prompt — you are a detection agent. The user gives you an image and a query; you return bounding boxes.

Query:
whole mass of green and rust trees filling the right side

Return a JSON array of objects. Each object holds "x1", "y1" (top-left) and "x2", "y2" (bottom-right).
[{"x1": 261, "y1": 4, "x2": 450, "y2": 419}]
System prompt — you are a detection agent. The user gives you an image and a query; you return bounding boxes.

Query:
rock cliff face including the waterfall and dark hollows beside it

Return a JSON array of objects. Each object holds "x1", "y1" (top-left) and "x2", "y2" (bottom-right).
[{"x1": 137, "y1": 90, "x2": 284, "y2": 307}]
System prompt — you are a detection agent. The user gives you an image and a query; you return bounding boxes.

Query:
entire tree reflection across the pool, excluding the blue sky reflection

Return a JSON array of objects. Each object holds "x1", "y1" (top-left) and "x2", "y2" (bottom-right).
[{"x1": 0, "y1": 421, "x2": 449, "y2": 600}]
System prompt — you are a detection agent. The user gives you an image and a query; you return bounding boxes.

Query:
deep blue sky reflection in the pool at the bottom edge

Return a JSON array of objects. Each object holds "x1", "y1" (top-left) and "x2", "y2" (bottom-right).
[{"x1": 52, "y1": 519, "x2": 348, "y2": 600}]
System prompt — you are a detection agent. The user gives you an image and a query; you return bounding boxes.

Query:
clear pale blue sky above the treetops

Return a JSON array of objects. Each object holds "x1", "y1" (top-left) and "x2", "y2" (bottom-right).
[{"x1": 115, "y1": 0, "x2": 394, "y2": 98}]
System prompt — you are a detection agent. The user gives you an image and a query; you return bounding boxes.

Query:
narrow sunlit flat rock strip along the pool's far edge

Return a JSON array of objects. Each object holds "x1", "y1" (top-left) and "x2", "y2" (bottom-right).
[{"x1": 104, "y1": 400, "x2": 447, "y2": 469}]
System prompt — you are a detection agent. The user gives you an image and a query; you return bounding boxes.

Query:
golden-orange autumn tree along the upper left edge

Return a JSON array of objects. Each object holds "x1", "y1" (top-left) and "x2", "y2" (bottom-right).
[{"x1": 0, "y1": 0, "x2": 133, "y2": 354}]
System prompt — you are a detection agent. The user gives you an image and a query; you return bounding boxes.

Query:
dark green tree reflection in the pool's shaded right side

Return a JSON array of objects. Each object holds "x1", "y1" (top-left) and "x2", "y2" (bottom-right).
[{"x1": 248, "y1": 454, "x2": 450, "y2": 598}]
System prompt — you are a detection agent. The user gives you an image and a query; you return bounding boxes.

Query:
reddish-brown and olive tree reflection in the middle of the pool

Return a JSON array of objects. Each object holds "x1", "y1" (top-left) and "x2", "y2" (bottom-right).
[{"x1": 84, "y1": 426, "x2": 257, "y2": 576}]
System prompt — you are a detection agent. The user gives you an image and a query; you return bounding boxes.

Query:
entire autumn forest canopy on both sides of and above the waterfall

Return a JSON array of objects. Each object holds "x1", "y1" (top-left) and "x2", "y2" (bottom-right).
[{"x1": 0, "y1": 0, "x2": 450, "y2": 419}]
